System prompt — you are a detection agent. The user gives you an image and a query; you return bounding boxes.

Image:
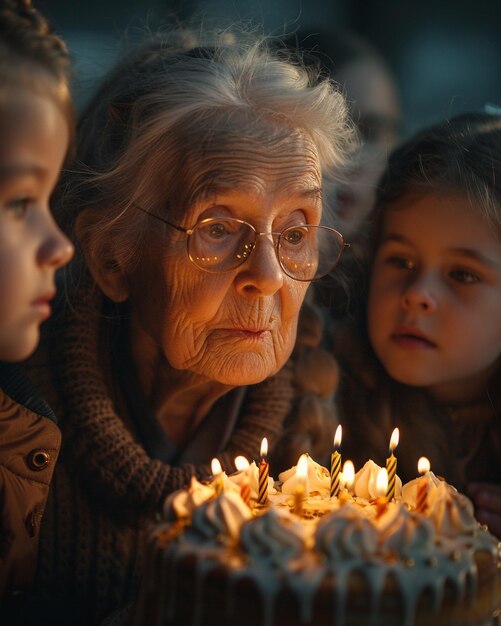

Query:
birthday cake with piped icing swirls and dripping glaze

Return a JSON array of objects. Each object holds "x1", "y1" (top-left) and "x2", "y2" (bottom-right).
[{"x1": 130, "y1": 458, "x2": 501, "y2": 626}]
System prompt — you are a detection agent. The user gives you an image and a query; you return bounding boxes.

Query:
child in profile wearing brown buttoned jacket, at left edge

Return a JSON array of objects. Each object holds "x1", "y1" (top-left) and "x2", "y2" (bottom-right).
[{"x1": 0, "y1": 0, "x2": 73, "y2": 600}]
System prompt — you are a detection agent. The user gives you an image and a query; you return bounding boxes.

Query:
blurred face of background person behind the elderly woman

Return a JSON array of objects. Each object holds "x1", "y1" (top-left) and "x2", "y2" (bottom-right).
[{"x1": 335, "y1": 59, "x2": 401, "y2": 233}]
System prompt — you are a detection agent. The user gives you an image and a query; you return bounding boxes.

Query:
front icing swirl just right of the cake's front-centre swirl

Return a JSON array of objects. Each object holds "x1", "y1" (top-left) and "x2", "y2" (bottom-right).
[{"x1": 378, "y1": 504, "x2": 435, "y2": 562}]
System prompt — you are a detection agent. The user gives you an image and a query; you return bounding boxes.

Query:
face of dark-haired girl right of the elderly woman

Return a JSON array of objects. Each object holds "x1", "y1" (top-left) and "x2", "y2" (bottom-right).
[{"x1": 368, "y1": 194, "x2": 501, "y2": 402}]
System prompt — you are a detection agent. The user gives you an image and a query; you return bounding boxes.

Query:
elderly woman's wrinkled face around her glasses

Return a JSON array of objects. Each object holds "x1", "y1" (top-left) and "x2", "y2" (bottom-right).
[{"x1": 129, "y1": 137, "x2": 321, "y2": 385}]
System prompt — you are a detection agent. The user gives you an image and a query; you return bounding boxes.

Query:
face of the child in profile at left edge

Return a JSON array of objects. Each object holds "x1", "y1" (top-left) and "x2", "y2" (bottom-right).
[{"x1": 0, "y1": 93, "x2": 73, "y2": 361}]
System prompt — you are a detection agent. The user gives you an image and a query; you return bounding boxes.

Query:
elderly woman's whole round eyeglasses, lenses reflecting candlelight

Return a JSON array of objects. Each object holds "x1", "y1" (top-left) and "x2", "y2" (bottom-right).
[{"x1": 134, "y1": 204, "x2": 350, "y2": 282}]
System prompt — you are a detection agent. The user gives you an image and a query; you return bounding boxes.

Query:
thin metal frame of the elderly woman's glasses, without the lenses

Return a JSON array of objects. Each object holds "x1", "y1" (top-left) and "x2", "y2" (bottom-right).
[{"x1": 133, "y1": 202, "x2": 351, "y2": 283}]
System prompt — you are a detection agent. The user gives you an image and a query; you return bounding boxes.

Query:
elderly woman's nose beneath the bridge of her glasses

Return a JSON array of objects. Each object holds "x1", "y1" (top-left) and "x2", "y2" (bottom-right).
[{"x1": 235, "y1": 235, "x2": 284, "y2": 295}]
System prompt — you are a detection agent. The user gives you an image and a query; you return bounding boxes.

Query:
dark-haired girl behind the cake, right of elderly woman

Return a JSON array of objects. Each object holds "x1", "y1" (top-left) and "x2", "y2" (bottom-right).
[{"x1": 336, "y1": 113, "x2": 501, "y2": 536}]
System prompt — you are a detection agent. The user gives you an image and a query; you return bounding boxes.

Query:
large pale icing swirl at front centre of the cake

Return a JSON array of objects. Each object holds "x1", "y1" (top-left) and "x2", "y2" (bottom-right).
[{"x1": 315, "y1": 504, "x2": 378, "y2": 562}]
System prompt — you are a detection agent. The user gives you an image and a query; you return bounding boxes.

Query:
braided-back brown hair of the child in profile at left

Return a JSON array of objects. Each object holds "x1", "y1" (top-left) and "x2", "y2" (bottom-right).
[{"x1": 0, "y1": 0, "x2": 75, "y2": 145}]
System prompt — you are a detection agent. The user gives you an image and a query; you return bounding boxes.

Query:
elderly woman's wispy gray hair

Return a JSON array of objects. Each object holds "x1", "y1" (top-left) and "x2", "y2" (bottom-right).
[{"x1": 56, "y1": 33, "x2": 355, "y2": 272}]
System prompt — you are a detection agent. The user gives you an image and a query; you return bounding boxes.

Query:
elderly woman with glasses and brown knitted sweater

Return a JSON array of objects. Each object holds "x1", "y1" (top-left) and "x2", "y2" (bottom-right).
[{"x1": 27, "y1": 30, "x2": 352, "y2": 624}]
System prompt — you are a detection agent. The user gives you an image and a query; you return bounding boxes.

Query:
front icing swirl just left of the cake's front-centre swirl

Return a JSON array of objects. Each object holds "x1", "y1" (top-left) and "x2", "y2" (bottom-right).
[{"x1": 240, "y1": 509, "x2": 306, "y2": 568}]
